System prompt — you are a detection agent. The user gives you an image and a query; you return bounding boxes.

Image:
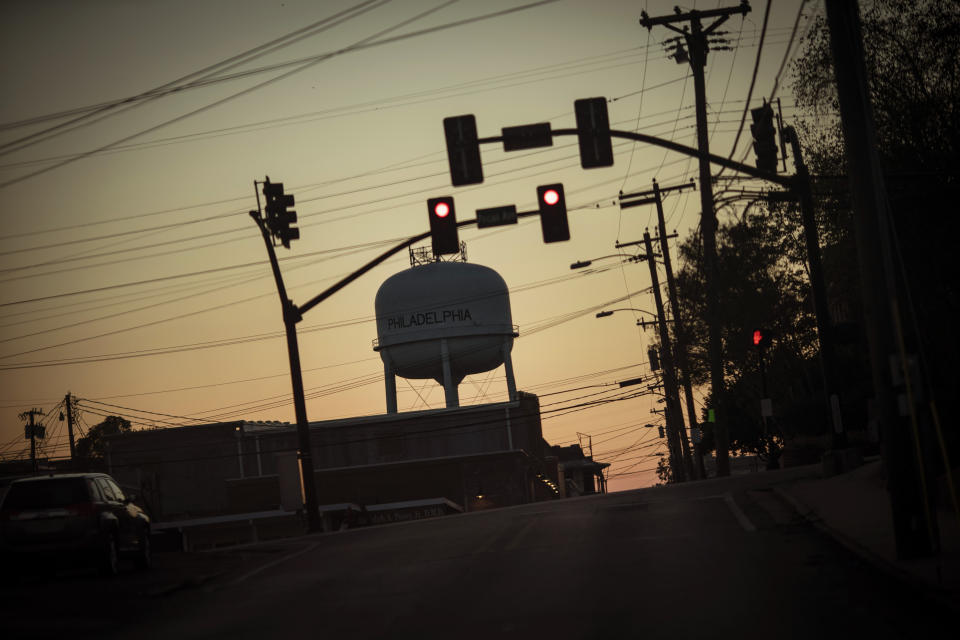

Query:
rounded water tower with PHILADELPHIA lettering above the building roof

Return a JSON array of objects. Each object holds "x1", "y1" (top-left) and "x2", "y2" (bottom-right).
[{"x1": 373, "y1": 262, "x2": 518, "y2": 413}]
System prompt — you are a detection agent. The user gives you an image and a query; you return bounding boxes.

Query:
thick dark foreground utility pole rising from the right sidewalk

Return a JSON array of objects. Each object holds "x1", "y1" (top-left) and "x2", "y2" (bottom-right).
[{"x1": 825, "y1": 0, "x2": 937, "y2": 559}]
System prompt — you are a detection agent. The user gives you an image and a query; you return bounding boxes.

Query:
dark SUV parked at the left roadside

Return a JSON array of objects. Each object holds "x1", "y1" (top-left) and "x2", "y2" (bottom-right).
[{"x1": 0, "y1": 473, "x2": 151, "y2": 575}]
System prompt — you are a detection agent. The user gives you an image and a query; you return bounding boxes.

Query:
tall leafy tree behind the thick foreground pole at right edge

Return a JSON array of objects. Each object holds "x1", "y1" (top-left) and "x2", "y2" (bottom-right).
[{"x1": 793, "y1": 0, "x2": 960, "y2": 460}]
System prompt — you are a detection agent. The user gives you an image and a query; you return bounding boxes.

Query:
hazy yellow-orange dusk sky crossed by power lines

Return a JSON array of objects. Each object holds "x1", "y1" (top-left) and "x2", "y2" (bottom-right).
[{"x1": 0, "y1": 0, "x2": 823, "y2": 490}]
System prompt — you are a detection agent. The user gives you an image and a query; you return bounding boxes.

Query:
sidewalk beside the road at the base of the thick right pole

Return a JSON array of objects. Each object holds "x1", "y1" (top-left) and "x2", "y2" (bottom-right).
[{"x1": 775, "y1": 460, "x2": 960, "y2": 610}]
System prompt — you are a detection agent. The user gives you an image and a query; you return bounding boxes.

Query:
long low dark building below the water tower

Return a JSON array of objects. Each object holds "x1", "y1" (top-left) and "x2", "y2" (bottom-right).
[{"x1": 107, "y1": 392, "x2": 565, "y2": 521}]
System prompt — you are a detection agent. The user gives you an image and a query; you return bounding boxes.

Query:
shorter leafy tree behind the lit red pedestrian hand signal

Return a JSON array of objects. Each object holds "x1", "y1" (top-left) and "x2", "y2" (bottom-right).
[{"x1": 677, "y1": 203, "x2": 822, "y2": 456}]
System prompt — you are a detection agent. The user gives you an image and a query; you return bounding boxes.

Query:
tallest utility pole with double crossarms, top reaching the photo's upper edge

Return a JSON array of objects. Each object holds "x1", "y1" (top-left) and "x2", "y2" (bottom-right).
[{"x1": 640, "y1": 0, "x2": 750, "y2": 476}]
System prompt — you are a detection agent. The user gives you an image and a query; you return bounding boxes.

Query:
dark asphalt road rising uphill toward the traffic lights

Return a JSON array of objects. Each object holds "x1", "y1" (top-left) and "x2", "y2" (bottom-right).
[{"x1": 3, "y1": 472, "x2": 956, "y2": 639}]
